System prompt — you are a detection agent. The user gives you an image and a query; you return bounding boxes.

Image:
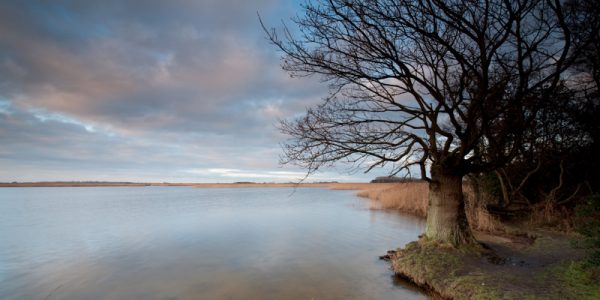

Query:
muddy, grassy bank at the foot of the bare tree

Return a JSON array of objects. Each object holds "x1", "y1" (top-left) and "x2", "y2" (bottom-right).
[{"x1": 390, "y1": 232, "x2": 600, "y2": 299}]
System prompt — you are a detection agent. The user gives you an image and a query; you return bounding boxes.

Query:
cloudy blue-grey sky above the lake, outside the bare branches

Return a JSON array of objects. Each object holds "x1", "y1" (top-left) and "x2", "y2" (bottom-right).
[{"x1": 0, "y1": 0, "x2": 390, "y2": 182}]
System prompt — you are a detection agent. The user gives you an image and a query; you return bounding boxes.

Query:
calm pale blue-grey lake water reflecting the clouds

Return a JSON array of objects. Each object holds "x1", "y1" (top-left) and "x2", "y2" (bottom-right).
[{"x1": 0, "y1": 187, "x2": 425, "y2": 299}]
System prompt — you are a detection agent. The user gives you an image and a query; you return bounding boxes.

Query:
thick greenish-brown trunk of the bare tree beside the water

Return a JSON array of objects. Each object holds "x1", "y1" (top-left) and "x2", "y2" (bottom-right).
[{"x1": 425, "y1": 166, "x2": 475, "y2": 246}]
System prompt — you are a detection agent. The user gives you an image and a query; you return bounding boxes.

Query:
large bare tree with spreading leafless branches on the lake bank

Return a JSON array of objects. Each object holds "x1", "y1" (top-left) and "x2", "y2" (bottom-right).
[{"x1": 263, "y1": 0, "x2": 597, "y2": 244}]
